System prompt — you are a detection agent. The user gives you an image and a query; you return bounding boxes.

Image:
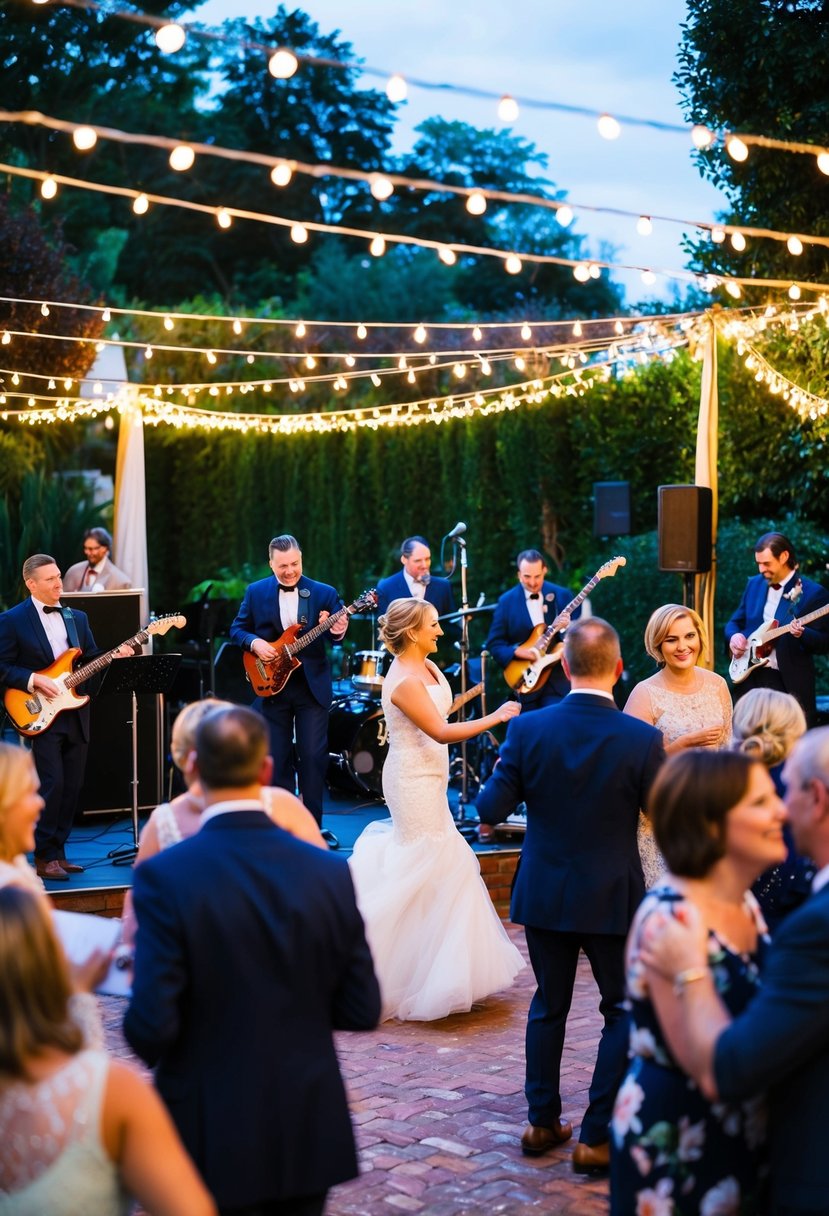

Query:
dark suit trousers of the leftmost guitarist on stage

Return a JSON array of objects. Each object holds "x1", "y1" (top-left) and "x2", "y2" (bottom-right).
[{"x1": 32, "y1": 710, "x2": 89, "y2": 861}]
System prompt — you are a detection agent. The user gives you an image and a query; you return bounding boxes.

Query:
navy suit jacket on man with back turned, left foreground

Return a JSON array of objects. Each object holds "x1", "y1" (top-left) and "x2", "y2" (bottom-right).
[{"x1": 124, "y1": 809, "x2": 380, "y2": 1207}]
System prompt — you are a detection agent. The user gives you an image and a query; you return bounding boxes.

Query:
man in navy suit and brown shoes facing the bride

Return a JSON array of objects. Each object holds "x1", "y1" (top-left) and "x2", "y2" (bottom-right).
[{"x1": 476, "y1": 617, "x2": 665, "y2": 1172}]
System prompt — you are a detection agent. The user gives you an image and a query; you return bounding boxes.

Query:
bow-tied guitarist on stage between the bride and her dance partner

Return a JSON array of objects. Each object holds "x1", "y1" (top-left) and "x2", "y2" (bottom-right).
[{"x1": 484, "y1": 548, "x2": 582, "y2": 713}]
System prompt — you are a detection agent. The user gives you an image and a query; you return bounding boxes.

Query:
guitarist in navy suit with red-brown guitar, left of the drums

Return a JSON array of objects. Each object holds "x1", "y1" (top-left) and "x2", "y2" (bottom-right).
[{"x1": 230, "y1": 534, "x2": 349, "y2": 843}]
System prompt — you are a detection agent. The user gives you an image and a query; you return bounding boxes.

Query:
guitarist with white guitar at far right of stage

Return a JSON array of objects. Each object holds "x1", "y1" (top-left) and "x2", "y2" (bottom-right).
[{"x1": 726, "y1": 533, "x2": 829, "y2": 727}]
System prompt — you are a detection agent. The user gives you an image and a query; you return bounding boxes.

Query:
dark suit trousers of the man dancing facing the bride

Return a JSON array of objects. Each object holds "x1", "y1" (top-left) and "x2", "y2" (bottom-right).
[{"x1": 524, "y1": 925, "x2": 628, "y2": 1144}]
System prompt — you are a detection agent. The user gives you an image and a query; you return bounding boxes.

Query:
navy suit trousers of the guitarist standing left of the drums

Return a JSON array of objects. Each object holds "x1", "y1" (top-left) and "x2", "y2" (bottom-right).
[{"x1": 258, "y1": 668, "x2": 328, "y2": 823}]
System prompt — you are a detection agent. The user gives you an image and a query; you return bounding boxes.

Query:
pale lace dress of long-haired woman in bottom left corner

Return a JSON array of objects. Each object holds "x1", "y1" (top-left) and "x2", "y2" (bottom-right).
[{"x1": 0, "y1": 1052, "x2": 130, "y2": 1216}]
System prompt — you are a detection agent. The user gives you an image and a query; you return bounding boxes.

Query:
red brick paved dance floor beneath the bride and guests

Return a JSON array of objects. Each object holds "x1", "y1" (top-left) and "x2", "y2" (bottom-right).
[{"x1": 102, "y1": 927, "x2": 608, "y2": 1216}]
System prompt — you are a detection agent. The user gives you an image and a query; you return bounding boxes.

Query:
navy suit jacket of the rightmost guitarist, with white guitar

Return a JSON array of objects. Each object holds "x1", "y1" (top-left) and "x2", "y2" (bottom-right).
[{"x1": 726, "y1": 570, "x2": 829, "y2": 720}]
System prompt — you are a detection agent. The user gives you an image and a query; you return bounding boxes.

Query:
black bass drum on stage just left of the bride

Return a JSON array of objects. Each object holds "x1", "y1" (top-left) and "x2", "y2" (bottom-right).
[{"x1": 328, "y1": 696, "x2": 389, "y2": 801}]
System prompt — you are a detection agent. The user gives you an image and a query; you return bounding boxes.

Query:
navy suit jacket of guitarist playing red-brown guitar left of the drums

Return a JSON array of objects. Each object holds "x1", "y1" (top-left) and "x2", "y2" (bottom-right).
[{"x1": 230, "y1": 575, "x2": 343, "y2": 709}]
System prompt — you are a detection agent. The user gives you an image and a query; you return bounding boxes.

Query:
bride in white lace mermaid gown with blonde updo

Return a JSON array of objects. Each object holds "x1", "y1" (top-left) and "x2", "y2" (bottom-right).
[{"x1": 350, "y1": 597, "x2": 524, "y2": 1021}]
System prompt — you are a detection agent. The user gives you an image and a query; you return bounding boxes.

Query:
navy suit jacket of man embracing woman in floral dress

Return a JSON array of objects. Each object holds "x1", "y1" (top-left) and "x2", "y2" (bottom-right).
[{"x1": 715, "y1": 886, "x2": 829, "y2": 1212}]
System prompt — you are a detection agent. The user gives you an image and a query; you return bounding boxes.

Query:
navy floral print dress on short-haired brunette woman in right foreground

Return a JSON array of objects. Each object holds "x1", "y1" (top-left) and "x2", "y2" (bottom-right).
[{"x1": 610, "y1": 884, "x2": 768, "y2": 1216}]
